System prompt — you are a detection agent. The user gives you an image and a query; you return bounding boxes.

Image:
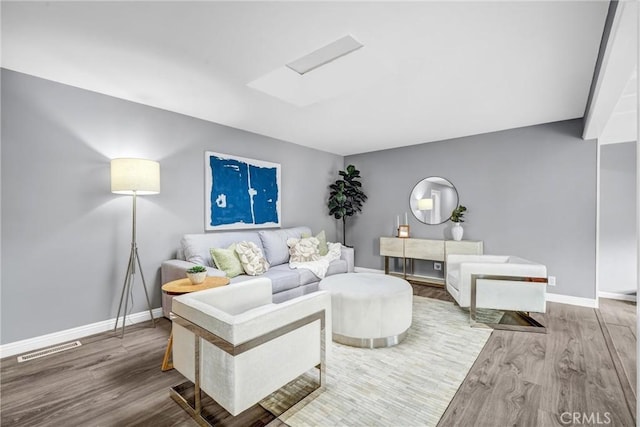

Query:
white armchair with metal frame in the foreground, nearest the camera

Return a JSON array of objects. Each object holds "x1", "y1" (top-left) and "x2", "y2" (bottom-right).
[{"x1": 171, "y1": 278, "x2": 331, "y2": 422}]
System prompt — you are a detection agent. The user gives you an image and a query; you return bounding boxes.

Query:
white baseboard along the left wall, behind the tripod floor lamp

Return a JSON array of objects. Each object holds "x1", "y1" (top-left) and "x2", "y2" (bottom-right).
[{"x1": 0, "y1": 308, "x2": 162, "y2": 358}]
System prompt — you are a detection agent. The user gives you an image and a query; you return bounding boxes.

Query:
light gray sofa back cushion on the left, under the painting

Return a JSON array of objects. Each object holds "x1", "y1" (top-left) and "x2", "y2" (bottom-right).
[{"x1": 180, "y1": 231, "x2": 262, "y2": 267}]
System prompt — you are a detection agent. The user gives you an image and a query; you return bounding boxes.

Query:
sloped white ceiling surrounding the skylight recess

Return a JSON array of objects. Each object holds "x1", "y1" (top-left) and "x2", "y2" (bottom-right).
[{"x1": 2, "y1": 1, "x2": 608, "y2": 155}]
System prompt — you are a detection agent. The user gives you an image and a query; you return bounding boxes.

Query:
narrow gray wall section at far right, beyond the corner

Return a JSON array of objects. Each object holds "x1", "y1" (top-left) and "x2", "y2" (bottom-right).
[{"x1": 598, "y1": 142, "x2": 638, "y2": 294}]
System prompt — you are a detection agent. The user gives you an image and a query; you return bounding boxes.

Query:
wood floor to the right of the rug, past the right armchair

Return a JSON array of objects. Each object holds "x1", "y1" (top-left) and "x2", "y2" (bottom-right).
[{"x1": 413, "y1": 284, "x2": 636, "y2": 427}]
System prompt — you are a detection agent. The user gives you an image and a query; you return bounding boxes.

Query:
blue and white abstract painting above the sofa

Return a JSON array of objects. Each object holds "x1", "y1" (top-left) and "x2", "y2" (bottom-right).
[{"x1": 205, "y1": 151, "x2": 280, "y2": 230}]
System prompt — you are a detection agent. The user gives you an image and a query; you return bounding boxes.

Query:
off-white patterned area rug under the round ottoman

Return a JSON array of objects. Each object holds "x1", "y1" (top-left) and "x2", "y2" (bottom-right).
[{"x1": 268, "y1": 296, "x2": 491, "y2": 427}]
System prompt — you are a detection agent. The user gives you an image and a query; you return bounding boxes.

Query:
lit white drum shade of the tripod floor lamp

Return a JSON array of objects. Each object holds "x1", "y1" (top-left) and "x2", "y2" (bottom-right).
[{"x1": 111, "y1": 159, "x2": 160, "y2": 195}]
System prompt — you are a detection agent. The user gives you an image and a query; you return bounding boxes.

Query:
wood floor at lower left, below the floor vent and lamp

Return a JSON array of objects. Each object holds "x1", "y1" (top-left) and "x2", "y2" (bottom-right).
[{"x1": 0, "y1": 318, "x2": 202, "y2": 427}]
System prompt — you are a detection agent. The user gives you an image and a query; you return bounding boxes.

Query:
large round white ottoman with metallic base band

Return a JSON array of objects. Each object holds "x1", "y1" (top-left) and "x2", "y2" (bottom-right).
[{"x1": 319, "y1": 273, "x2": 413, "y2": 348}]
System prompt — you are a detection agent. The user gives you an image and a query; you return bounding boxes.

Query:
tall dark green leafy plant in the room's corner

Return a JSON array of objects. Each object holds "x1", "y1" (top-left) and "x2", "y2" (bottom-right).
[{"x1": 327, "y1": 165, "x2": 367, "y2": 245}]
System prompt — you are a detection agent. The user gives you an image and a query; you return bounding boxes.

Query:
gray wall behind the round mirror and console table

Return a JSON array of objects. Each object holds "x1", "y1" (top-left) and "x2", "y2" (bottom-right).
[{"x1": 345, "y1": 120, "x2": 597, "y2": 298}]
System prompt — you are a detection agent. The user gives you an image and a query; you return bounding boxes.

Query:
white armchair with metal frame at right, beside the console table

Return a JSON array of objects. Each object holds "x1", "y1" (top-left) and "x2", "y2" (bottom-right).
[{"x1": 446, "y1": 254, "x2": 547, "y2": 332}]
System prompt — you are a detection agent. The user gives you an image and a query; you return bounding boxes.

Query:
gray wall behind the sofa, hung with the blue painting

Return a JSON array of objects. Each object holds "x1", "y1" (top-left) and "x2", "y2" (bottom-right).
[{"x1": 1, "y1": 70, "x2": 343, "y2": 344}]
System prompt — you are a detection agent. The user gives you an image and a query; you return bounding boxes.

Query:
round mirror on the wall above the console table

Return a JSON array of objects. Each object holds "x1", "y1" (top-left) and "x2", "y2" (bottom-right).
[{"x1": 409, "y1": 176, "x2": 458, "y2": 225}]
